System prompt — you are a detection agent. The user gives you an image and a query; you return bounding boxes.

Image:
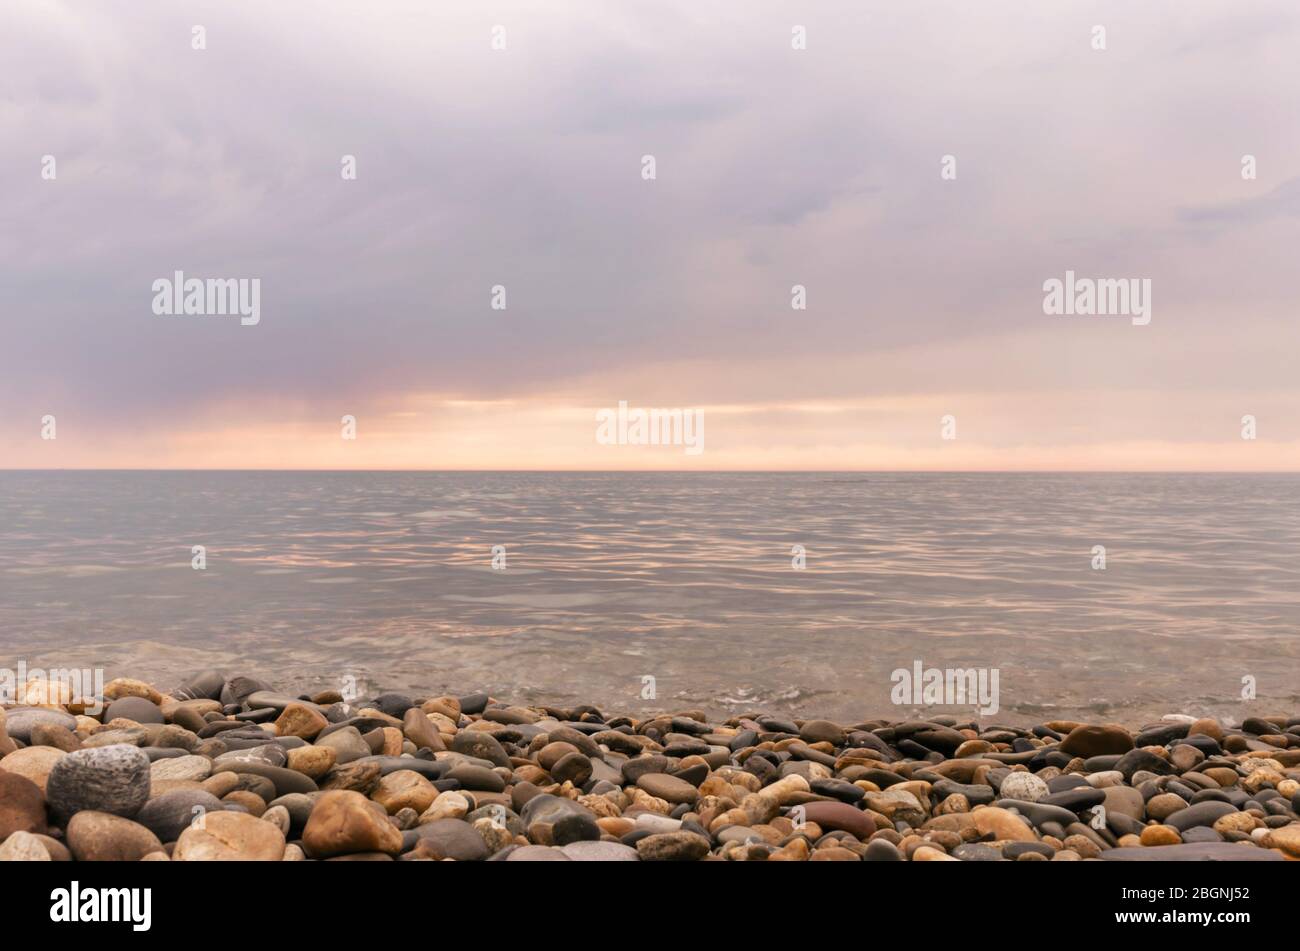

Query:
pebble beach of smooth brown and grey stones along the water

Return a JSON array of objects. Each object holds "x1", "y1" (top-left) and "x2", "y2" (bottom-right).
[{"x1": 0, "y1": 670, "x2": 1300, "y2": 861}]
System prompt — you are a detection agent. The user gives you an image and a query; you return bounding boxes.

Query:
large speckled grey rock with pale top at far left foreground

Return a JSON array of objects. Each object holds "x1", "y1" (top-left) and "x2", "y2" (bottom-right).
[{"x1": 46, "y1": 743, "x2": 150, "y2": 818}]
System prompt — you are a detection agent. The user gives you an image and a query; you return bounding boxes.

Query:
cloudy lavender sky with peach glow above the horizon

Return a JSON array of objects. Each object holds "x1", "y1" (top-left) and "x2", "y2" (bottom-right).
[{"x1": 0, "y1": 0, "x2": 1300, "y2": 470}]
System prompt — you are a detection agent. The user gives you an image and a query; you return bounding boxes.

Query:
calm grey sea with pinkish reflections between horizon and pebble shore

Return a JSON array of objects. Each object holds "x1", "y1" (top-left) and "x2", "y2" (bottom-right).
[{"x1": 0, "y1": 472, "x2": 1300, "y2": 722}]
